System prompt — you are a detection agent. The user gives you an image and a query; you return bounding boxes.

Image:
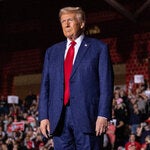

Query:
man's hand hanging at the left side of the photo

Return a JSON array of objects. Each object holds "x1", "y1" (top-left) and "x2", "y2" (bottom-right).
[{"x1": 40, "y1": 119, "x2": 50, "y2": 138}]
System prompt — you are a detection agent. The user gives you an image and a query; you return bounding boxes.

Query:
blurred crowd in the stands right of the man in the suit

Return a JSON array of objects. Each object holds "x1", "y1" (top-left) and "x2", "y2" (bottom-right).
[{"x1": 105, "y1": 84, "x2": 150, "y2": 150}]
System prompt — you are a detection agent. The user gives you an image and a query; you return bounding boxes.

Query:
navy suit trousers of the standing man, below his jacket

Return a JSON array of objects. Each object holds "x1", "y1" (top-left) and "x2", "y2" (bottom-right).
[{"x1": 53, "y1": 106, "x2": 103, "y2": 150}]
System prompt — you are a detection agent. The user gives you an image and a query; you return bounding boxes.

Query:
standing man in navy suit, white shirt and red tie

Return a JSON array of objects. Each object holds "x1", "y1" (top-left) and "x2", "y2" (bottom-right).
[{"x1": 39, "y1": 7, "x2": 113, "y2": 150}]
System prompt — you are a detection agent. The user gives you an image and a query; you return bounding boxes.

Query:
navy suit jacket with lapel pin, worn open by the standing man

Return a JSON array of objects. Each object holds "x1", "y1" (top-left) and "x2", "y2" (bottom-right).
[{"x1": 39, "y1": 37, "x2": 113, "y2": 134}]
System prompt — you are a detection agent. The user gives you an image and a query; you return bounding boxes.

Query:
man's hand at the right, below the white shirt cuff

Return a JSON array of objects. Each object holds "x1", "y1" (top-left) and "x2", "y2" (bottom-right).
[{"x1": 95, "y1": 116, "x2": 108, "y2": 136}]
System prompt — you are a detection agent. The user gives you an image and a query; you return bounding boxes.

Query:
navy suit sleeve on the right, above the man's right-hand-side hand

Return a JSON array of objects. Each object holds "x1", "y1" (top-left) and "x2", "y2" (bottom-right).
[{"x1": 98, "y1": 45, "x2": 114, "y2": 119}]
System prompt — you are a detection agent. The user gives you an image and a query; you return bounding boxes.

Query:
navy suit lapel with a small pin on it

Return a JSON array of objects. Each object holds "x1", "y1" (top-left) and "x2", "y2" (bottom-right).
[{"x1": 71, "y1": 38, "x2": 90, "y2": 77}]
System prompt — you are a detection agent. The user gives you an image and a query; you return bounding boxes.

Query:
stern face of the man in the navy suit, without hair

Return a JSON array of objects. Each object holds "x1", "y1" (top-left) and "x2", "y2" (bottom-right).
[{"x1": 60, "y1": 13, "x2": 84, "y2": 40}]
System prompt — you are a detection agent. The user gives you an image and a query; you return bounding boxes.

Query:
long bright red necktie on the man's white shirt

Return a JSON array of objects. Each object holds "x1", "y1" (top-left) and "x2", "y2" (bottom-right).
[{"x1": 64, "y1": 41, "x2": 76, "y2": 105}]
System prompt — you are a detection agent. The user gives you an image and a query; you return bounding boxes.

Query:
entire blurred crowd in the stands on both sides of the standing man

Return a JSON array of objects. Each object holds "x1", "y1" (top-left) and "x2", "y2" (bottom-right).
[{"x1": 0, "y1": 82, "x2": 150, "y2": 150}]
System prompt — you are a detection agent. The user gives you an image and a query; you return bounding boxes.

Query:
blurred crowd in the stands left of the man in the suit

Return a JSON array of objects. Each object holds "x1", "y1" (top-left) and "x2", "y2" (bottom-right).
[{"x1": 0, "y1": 93, "x2": 53, "y2": 150}]
